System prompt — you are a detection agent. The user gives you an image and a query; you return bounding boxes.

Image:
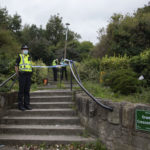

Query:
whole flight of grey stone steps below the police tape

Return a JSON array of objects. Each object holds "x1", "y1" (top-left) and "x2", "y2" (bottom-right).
[{"x1": 0, "y1": 90, "x2": 95, "y2": 145}]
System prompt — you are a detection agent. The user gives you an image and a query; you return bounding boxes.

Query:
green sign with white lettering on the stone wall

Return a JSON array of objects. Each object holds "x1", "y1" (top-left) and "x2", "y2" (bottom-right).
[{"x1": 135, "y1": 109, "x2": 150, "y2": 132}]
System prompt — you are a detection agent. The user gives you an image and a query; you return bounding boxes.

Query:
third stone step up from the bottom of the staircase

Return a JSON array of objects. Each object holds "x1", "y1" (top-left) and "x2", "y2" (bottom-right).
[{"x1": 0, "y1": 116, "x2": 80, "y2": 125}]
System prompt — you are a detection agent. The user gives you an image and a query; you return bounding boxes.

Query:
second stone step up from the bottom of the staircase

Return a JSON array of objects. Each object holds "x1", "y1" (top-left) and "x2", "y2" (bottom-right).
[{"x1": 0, "y1": 124, "x2": 84, "y2": 135}]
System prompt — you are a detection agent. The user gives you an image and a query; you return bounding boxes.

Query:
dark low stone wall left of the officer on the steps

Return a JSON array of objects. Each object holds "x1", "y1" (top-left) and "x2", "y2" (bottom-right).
[{"x1": 0, "y1": 92, "x2": 17, "y2": 118}]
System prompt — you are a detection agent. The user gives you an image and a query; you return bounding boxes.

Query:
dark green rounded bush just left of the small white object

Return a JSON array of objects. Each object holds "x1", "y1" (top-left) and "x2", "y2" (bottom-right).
[{"x1": 104, "y1": 69, "x2": 141, "y2": 95}]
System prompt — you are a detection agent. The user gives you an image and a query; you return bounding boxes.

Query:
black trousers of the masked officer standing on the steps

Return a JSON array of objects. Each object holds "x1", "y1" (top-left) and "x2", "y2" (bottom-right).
[{"x1": 18, "y1": 72, "x2": 32, "y2": 107}]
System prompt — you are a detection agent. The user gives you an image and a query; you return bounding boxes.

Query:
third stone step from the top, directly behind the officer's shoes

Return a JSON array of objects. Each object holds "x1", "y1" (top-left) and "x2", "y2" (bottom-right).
[{"x1": 15, "y1": 102, "x2": 74, "y2": 109}]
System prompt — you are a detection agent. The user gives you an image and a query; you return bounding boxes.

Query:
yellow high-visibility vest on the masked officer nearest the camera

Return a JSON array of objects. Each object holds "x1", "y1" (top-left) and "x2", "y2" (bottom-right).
[{"x1": 19, "y1": 54, "x2": 32, "y2": 72}]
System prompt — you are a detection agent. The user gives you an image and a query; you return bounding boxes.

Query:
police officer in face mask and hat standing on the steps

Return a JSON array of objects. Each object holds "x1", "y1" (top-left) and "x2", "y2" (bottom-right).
[{"x1": 15, "y1": 45, "x2": 32, "y2": 111}]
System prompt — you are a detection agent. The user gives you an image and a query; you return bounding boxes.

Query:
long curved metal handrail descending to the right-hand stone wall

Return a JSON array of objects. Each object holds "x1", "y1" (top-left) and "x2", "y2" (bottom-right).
[{"x1": 68, "y1": 60, "x2": 113, "y2": 111}]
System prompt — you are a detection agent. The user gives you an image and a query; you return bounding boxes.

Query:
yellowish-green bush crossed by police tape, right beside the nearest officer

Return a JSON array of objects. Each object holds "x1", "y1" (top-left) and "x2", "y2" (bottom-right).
[{"x1": 32, "y1": 60, "x2": 48, "y2": 84}]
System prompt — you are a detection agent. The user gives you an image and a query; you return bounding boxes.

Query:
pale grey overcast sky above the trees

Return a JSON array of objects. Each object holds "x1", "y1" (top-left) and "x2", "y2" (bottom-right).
[{"x1": 0, "y1": 0, "x2": 148, "y2": 44}]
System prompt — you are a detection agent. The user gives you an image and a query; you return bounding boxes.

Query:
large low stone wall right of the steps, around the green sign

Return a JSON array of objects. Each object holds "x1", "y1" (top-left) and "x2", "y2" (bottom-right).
[{"x1": 75, "y1": 93, "x2": 150, "y2": 150}]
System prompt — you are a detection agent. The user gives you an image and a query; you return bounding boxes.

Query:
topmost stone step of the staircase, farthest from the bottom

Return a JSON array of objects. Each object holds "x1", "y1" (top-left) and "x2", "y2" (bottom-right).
[{"x1": 30, "y1": 90, "x2": 72, "y2": 96}]
